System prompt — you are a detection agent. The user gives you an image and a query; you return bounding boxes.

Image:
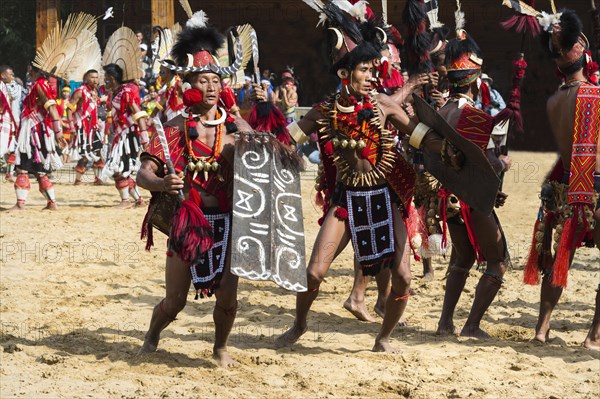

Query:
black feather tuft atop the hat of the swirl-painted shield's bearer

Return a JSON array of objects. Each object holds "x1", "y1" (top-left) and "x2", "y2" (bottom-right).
[{"x1": 171, "y1": 27, "x2": 225, "y2": 65}]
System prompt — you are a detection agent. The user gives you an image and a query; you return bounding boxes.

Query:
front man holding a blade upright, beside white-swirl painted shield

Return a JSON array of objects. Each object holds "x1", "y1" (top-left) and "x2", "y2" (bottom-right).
[{"x1": 137, "y1": 11, "x2": 270, "y2": 367}]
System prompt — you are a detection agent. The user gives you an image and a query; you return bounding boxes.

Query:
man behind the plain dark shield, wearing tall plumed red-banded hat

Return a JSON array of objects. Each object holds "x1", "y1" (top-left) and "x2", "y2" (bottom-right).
[{"x1": 437, "y1": 5, "x2": 510, "y2": 338}]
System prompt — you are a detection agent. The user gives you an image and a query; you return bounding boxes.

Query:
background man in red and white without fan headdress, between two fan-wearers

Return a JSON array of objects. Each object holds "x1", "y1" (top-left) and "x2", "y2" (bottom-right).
[{"x1": 67, "y1": 69, "x2": 105, "y2": 185}]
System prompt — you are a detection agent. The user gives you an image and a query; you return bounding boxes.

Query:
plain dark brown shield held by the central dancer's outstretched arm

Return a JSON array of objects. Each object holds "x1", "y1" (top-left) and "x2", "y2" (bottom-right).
[{"x1": 413, "y1": 94, "x2": 500, "y2": 215}]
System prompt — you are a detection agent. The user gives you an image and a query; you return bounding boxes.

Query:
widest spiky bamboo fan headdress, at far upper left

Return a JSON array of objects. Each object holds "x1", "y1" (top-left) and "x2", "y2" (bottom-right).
[{"x1": 33, "y1": 13, "x2": 96, "y2": 80}]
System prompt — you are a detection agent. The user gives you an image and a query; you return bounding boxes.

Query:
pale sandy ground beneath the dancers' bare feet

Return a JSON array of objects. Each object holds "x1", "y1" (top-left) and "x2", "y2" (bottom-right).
[{"x1": 0, "y1": 153, "x2": 600, "y2": 398}]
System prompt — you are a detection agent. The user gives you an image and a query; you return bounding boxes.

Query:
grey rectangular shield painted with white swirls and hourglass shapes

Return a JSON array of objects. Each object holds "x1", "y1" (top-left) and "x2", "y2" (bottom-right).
[{"x1": 231, "y1": 133, "x2": 307, "y2": 292}]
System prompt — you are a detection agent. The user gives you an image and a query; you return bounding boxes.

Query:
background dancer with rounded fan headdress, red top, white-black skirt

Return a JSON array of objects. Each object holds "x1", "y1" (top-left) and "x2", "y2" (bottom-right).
[{"x1": 102, "y1": 27, "x2": 149, "y2": 208}]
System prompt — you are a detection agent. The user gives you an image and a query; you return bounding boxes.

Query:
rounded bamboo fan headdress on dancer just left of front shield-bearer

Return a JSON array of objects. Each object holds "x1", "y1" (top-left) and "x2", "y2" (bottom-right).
[{"x1": 102, "y1": 26, "x2": 144, "y2": 82}]
